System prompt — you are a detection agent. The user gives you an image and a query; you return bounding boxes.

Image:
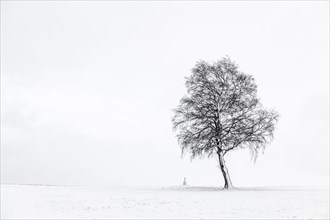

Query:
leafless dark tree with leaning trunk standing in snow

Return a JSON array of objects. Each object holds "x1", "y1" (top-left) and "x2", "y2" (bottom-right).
[{"x1": 172, "y1": 58, "x2": 278, "y2": 189}]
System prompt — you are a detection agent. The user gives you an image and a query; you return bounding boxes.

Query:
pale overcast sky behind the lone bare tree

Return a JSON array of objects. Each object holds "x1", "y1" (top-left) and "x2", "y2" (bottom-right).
[{"x1": 1, "y1": 1, "x2": 329, "y2": 186}]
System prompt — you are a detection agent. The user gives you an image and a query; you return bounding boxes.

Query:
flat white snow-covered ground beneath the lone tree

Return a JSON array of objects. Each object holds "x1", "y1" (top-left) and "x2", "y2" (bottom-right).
[{"x1": 1, "y1": 185, "x2": 329, "y2": 219}]
